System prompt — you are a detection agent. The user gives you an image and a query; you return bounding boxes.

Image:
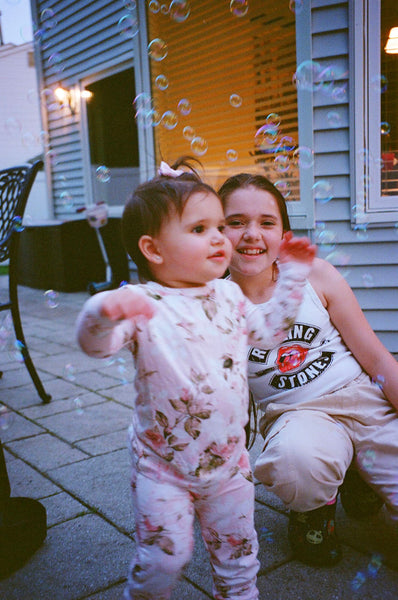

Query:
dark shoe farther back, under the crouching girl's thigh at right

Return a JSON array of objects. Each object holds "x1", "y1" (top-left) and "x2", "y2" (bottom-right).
[{"x1": 339, "y1": 469, "x2": 384, "y2": 521}]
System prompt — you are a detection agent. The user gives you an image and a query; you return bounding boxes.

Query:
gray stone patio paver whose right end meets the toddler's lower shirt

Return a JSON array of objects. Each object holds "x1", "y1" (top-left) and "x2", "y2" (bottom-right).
[{"x1": 37, "y1": 400, "x2": 132, "y2": 442}]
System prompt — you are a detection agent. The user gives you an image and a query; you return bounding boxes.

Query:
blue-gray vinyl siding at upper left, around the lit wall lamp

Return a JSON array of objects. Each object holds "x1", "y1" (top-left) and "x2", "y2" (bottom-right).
[{"x1": 31, "y1": 0, "x2": 134, "y2": 219}]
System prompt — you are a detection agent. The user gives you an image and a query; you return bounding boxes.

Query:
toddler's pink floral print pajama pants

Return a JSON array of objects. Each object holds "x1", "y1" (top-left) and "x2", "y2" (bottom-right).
[{"x1": 124, "y1": 458, "x2": 259, "y2": 600}]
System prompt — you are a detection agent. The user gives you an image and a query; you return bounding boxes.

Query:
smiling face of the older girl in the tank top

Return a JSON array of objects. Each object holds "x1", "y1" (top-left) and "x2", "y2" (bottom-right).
[{"x1": 224, "y1": 185, "x2": 284, "y2": 278}]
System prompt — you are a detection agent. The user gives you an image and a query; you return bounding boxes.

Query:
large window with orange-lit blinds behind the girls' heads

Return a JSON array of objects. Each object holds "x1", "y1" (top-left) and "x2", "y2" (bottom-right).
[{"x1": 145, "y1": 0, "x2": 299, "y2": 201}]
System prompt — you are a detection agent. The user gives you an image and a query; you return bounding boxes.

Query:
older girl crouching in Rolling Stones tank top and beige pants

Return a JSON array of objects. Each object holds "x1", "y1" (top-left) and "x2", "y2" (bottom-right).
[{"x1": 219, "y1": 173, "x2": 398, "y2": 565}]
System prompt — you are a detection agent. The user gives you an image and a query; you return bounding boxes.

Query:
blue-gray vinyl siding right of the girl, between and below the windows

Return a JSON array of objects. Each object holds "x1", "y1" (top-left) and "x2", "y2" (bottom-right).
[{"x1": 311, "y1": 0, "x2": 398, "y2": 355}]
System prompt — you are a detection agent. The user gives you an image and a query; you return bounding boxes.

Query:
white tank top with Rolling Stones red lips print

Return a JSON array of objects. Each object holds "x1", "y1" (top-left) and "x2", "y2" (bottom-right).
[{"x1": 248, "y1": 281, "x2": 362, "y2": 411}]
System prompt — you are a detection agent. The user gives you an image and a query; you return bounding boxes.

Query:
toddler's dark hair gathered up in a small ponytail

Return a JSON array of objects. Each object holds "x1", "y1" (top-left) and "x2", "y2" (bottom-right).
[{"x1": 122, "y1": 156, "x2": 217, "y2": 281}]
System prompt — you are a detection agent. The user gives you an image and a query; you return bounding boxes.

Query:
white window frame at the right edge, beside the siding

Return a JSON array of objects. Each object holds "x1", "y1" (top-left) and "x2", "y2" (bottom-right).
[{"x1": 350, "y1": 0, "x2": 398, "y2": 226}]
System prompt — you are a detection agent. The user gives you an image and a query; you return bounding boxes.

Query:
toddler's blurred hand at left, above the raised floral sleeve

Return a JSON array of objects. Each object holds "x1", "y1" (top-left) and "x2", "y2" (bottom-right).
[{"x1": 100, "y1": 286, "x2": 155, "y2": 321}]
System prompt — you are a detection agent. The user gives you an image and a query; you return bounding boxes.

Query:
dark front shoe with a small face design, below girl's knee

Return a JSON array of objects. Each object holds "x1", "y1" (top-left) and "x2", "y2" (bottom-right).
[{"x1": 288, "y1": 502, "x2": 342, "y2": 567}]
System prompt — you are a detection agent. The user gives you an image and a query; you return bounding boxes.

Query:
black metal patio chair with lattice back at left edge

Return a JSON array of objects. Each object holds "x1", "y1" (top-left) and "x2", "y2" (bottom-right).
[{"x1": 0, "y1": 160, "x2": 51, "y2": 404}]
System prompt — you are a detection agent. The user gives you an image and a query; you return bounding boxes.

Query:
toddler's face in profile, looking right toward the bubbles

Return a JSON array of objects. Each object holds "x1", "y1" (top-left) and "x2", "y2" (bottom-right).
[{"x1": 152, "y1": 192, "x2": 232, "y2": 287}]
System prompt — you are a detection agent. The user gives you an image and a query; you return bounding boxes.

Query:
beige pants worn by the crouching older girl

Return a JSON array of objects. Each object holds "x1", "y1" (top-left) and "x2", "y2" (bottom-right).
[{"x1": 254, "y1": 373, "x2": 398, "y2": 521}]
